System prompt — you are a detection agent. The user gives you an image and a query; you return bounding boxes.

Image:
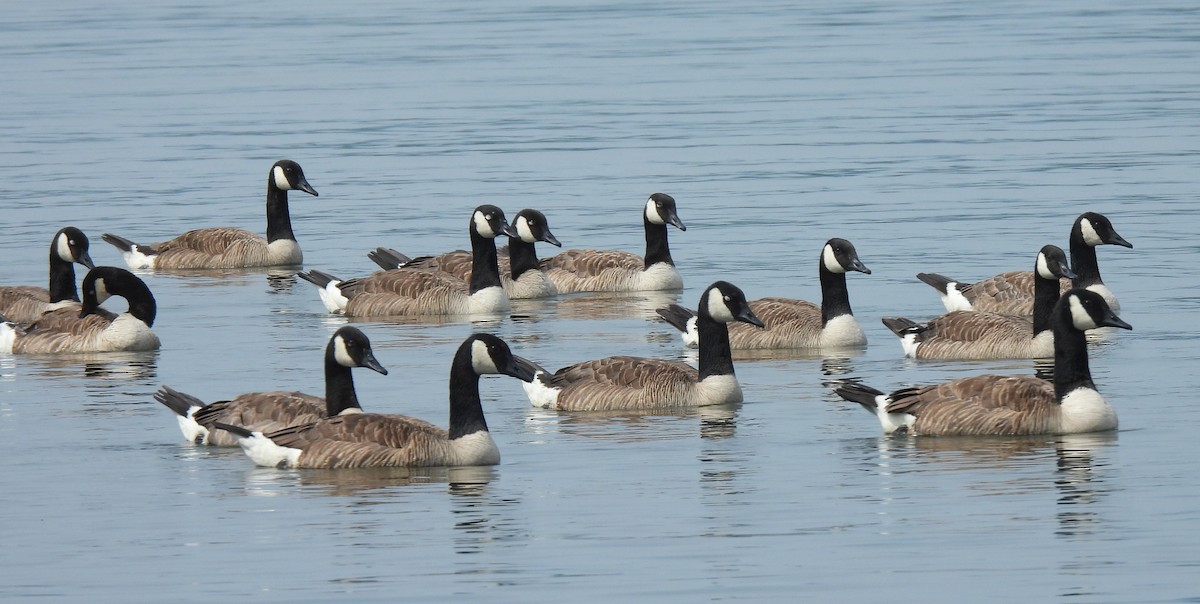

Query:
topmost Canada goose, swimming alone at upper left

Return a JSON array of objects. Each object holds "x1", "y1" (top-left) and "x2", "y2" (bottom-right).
[{"x1": 101, "y1": 160, "x2": 317, "y2": 269}]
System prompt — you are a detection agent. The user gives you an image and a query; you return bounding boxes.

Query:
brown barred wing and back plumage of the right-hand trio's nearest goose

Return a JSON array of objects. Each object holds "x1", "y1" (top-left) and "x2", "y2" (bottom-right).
[{"x1": 887, "y1": 376, "x2": 1060, "y2": 436}]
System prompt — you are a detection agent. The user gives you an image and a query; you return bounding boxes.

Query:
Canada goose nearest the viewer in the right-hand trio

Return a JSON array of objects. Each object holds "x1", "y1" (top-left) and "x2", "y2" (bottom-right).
[{"x1": 835, "y1": 288, "x2": 1132, "y2": 436}]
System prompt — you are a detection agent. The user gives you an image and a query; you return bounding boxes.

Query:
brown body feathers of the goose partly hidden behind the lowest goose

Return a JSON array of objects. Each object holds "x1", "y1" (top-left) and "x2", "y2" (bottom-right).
[{"x1": 192, "y1": 391, "x2": 325, "y2": 447}]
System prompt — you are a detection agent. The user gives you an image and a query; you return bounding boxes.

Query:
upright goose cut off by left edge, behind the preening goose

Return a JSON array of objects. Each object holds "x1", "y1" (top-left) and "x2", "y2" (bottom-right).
[{"x1": 0, "y1": 227, "x2": 96, "y2": 324}]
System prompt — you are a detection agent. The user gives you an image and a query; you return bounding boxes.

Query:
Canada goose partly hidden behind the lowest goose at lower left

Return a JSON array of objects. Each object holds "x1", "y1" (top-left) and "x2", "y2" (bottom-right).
[{"x1": 154, "y1": 325, "x2": 388, "y2": 447}]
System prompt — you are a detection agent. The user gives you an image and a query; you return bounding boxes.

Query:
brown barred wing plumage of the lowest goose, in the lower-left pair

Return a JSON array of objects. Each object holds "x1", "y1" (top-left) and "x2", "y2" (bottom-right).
[{"x1": 266, "y1": 413, "x2": 449, "y2": 468}]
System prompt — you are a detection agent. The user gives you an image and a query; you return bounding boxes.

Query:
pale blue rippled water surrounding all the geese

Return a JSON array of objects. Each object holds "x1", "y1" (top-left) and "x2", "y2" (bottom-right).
[{"x1": 0, "y1": 0, "x2": 1200, "y2": 603}]
